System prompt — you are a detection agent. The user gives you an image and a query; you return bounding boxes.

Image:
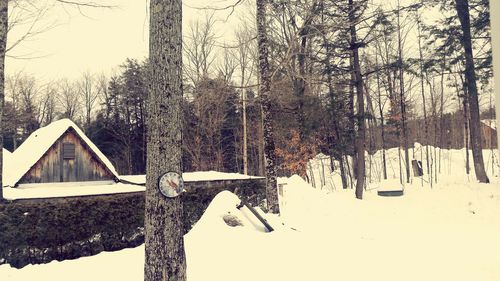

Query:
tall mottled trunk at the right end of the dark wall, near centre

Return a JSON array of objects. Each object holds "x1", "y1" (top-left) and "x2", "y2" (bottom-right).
[{"x1": 256, "y1": 0, "x2": 279, "y2": 214}]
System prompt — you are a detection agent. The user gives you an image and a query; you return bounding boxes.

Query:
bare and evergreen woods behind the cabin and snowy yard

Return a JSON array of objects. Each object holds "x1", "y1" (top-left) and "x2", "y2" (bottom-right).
[{"x1": 3, "y1": 0, "x2": 495, "y2": 198}]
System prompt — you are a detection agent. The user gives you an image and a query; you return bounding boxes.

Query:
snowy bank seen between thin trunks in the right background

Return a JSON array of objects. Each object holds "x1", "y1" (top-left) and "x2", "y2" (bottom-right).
[{"x1": 307, "y1": 143, "x2": 500, "y2": 191}]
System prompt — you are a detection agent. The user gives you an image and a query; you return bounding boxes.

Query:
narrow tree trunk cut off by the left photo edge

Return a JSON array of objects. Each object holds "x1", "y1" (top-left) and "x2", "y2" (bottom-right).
[{"x1": 0, "y1": 0, "x2": 9, "y2": 202}]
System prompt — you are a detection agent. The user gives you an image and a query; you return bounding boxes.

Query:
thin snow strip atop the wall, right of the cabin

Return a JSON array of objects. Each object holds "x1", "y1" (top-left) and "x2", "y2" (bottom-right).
[{"x1": 119, "y1": 171, "x2": 263, "y2": 184}]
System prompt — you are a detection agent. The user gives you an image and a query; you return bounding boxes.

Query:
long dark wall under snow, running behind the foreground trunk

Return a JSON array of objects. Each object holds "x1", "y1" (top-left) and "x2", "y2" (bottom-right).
[{"x1": 0, "y1": 179, "x2": 265, "y2": 268}]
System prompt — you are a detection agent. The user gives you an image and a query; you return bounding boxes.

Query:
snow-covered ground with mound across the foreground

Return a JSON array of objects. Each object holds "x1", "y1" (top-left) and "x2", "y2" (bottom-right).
[{"x1": 0, "y1": 147, "x2": 500, "y2": 281}]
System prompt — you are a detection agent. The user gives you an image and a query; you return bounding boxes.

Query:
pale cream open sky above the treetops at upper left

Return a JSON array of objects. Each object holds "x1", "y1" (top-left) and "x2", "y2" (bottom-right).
[{"x1": 6, "y1": 0, "x2": 248, "y2": 81}]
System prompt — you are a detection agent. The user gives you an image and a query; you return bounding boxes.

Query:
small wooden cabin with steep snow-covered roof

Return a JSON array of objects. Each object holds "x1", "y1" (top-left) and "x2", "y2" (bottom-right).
[{"x1": 4, "y1": 119, "x2": 118, "y2": 187}]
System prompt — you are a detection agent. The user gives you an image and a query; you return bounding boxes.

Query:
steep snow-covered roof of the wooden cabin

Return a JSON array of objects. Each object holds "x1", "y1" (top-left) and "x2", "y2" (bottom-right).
[{"x1": 3, "y1": 119, "x2": 118, "y2": 186}]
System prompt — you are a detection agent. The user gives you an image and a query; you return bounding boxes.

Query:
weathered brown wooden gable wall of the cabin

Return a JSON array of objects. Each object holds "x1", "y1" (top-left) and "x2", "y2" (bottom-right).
[{"x1": 19, "y1": 128, "x2": 115, "y2": 184}]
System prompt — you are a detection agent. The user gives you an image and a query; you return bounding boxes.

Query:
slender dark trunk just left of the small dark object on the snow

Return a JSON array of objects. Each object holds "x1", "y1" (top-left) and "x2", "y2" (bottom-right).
[{"x1": 349, "y1": 0, "x2": 365, "y2": 199}]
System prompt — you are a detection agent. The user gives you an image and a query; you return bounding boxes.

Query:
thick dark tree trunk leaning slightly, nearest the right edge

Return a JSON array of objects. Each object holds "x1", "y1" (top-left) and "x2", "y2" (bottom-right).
[{"x1": 455, "y1": 0, "x2": 490, "y2": 183}]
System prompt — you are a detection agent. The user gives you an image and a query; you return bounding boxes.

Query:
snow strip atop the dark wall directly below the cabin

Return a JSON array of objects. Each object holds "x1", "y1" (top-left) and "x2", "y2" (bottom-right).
[{"x1": 3, "y1": 182, "x2": 146, "y2": 200}]
